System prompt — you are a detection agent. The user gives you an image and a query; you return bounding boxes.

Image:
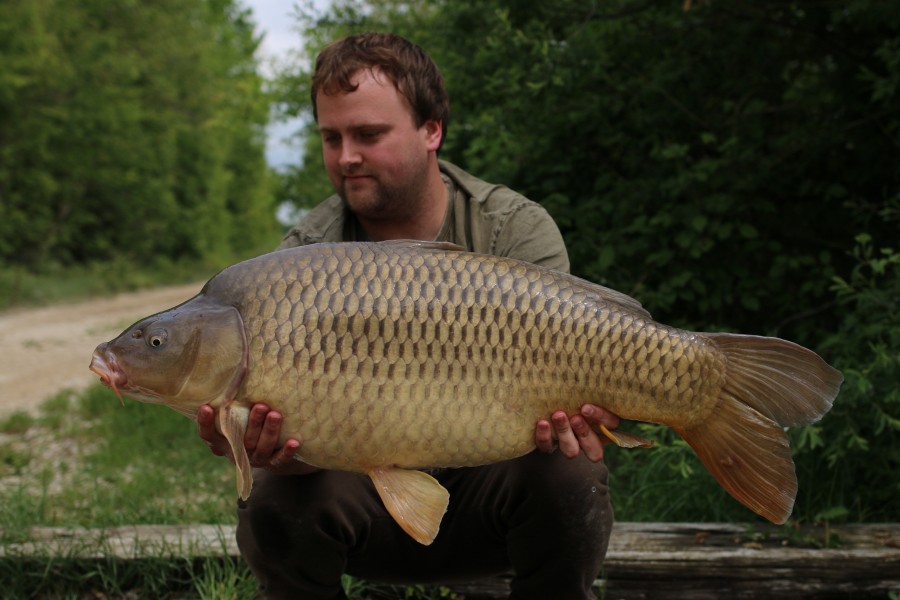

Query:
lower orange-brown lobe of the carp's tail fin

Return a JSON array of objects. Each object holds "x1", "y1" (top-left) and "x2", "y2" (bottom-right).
[{"x1": 675, "y1": 393, "x2": 797, "y2": 524}]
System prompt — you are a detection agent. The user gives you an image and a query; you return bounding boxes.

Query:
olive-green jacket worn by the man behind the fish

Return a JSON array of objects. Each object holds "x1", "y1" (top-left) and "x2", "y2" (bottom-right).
[{"x1": 279, "y1": 161, "x2": 569, "y2": 272}]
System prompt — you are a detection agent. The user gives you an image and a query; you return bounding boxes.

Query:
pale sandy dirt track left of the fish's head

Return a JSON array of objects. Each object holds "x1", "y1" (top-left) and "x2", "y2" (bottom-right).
[{"x1": 0, "y1": 283, "x2": 202, "y2": 416}]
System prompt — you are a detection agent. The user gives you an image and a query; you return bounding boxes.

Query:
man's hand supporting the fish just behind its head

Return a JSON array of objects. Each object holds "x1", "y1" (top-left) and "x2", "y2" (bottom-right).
[{"x1": 197, "y1": 404, "x2": 317, "y2": 474}]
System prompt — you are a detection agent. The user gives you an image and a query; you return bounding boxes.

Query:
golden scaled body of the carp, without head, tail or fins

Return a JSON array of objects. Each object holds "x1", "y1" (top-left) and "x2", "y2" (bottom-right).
[{"x1": 220, "y1": 245, "x2": 725, "y2": 471}]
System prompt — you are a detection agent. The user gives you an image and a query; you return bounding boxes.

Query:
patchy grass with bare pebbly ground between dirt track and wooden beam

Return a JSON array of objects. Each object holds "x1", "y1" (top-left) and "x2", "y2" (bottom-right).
[{"x1": 0, "y1": 385, "x2": 234, "y2": 530}]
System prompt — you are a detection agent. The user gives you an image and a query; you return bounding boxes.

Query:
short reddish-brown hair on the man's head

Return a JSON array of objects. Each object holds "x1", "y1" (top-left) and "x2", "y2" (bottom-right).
[{"x1": 310, "y1": 32, "x2": 450, "y2": 143}]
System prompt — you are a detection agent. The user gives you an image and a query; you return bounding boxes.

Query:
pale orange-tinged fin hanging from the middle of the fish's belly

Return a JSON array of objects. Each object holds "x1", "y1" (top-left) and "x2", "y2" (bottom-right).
[{"x1": 369, "y1": 467, "x2": 450, "y2": 546}]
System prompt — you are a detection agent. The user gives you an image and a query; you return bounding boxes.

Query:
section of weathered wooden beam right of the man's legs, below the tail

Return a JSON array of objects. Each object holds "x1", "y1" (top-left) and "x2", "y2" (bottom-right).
[{"x1": 604, "y1": 523, "x2": 900, "y2": 600}]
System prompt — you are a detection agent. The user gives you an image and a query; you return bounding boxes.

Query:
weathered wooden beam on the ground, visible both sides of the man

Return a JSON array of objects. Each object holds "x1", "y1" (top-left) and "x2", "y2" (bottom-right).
[{"x1": 0, "y1": 523, "x2": 900, "y2": 600}]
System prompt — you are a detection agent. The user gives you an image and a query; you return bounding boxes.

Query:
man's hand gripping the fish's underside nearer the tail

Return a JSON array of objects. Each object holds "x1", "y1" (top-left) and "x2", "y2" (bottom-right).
[{"x1": 534, "y1": 404, "x2": 619, "y2": 462}]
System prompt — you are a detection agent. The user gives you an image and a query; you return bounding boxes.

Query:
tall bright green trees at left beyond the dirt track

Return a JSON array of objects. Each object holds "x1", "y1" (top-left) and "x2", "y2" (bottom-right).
[{"x1": 0, "y1": 0, "x2": 276, "y2": 270}]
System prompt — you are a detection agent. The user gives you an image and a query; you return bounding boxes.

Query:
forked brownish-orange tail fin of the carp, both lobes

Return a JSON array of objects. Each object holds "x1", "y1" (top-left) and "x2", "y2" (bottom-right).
[{"x1": 675, "y1": 334, "x2": 843, "y2": 523}]
